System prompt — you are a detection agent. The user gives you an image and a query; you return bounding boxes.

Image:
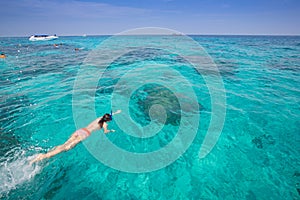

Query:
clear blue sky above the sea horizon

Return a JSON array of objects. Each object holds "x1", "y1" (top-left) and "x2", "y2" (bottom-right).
[{"x1": 0, "y1": 0, "x2": 300, "y2": 36}]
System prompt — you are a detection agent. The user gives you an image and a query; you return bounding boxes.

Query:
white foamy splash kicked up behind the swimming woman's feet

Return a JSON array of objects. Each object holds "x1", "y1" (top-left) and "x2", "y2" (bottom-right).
[{"x1": 0, "y1": 149, "x2": 41, "y2": 198}]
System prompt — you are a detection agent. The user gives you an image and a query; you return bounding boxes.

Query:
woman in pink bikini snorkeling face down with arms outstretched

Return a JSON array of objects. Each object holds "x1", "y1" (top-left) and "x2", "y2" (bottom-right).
[{"x1": 30, "y1": 110, "x2": 121, "y2": 164}]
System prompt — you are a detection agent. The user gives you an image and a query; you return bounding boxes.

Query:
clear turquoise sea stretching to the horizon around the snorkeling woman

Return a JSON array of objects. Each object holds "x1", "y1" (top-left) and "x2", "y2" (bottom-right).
[{"x1": 0, "y1": 35, "x2": 300, "y2": 200}]
